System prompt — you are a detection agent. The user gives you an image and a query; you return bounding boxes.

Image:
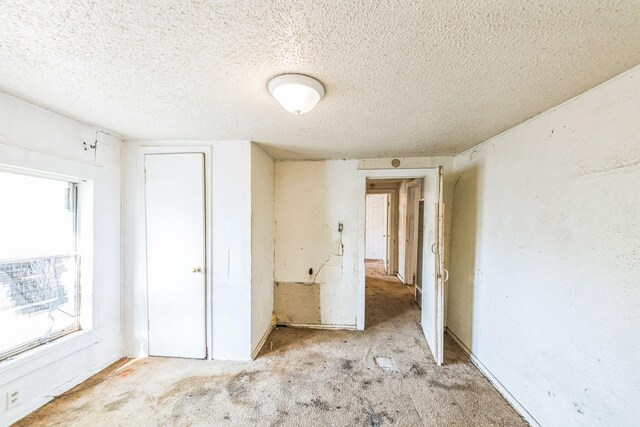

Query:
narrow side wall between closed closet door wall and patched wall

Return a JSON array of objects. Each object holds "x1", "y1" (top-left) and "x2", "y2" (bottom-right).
[{"x1": 251, "y1": 144, "x2": 275, "y2": 356}]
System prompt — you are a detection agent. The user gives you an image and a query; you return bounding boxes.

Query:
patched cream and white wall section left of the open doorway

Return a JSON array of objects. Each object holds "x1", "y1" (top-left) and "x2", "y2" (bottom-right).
[{"x1": 275, "y1": 160, "x2": 358, "y2": 328}]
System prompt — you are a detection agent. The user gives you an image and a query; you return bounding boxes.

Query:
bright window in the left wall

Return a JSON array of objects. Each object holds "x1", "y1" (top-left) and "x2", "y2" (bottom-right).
[{"x1": 0, "y1": 171, "x2": 80, "y2": 360}]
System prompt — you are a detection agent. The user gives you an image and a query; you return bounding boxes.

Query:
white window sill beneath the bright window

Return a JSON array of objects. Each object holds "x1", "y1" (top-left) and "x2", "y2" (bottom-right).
[{"x1": 0, "y1": 330, "x2": 98, "y2": 385}]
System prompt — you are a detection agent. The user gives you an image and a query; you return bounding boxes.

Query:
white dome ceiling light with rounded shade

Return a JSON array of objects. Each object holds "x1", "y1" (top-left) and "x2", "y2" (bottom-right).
[{"x1": 267, "y1": 74, "x2": 324, "y2": 114}]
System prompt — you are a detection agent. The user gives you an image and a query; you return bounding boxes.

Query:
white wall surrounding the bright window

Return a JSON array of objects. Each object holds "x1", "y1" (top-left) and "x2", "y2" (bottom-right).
[{"x1": 0, "y1": 93, "x2": 123, "y2": 425}]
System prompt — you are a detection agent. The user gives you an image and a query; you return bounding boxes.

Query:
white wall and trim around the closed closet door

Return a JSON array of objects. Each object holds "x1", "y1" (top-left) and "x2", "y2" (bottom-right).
[{"x1": 123, "y1": 141, "x2": 252, "y2": 360}]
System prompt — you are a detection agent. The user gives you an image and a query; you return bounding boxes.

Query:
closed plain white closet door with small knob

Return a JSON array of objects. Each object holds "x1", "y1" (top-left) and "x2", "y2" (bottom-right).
[{"x1": 145, "y1": 153, "x2": 206, "y2": 359}]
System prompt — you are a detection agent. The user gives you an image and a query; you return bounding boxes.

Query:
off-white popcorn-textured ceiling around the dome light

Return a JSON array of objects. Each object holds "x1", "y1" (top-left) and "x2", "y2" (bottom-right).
[{"x1": 0, "y1": 0, "x2": 640, "y2": 158}]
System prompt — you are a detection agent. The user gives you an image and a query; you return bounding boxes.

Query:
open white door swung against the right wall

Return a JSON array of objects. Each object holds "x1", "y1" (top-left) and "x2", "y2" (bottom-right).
[{"x1": 420, "y1": 166, "x2": 448, "y2": 365}]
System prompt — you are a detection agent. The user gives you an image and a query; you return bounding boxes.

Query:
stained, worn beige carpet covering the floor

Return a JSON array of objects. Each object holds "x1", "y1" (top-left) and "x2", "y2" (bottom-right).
[{"x1": 18, "y1": 262, "x2": 526, "y2": 427}]
